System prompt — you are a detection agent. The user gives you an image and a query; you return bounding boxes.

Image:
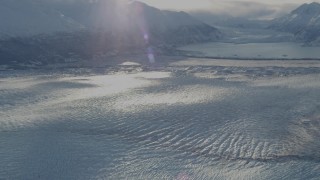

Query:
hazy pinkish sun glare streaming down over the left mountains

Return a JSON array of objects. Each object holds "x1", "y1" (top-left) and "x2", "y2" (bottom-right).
[{"x1": 94, "y1": 0, "x2": 156, "y2": 63}]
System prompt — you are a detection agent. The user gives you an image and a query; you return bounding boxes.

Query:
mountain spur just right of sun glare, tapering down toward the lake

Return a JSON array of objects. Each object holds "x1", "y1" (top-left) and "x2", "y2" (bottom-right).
[{"x1": 131, "y1": 2, "x2": 222, "y2": 44}]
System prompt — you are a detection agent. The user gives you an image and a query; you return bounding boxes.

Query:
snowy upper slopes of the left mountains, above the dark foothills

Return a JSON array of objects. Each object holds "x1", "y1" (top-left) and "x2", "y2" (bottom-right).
[{"x1": 0, "y1": 0, "x2": 221, "y2": 44}]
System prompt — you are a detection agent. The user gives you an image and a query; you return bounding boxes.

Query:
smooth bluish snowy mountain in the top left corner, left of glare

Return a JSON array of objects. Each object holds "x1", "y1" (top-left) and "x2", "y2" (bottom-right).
[{"x1": 0, "y1": 0, "x2": 83, "y2": 37}]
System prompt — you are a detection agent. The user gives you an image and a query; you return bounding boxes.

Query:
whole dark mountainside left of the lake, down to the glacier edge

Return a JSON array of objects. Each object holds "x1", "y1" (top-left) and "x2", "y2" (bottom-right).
[{"x1": 0, "y1": 0, "x2": 222, "y2": 65}]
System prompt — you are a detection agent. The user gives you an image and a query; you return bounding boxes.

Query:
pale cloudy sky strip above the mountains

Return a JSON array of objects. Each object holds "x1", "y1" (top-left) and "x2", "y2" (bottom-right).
[{"x1": 140, "y1": 0, "x2": 320, "y2": 18}]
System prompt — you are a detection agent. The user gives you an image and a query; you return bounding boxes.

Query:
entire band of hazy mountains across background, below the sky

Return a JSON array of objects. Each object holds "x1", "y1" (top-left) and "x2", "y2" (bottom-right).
[{"x1": 0, "y1": 0, "x2": 320, "y2": 68}]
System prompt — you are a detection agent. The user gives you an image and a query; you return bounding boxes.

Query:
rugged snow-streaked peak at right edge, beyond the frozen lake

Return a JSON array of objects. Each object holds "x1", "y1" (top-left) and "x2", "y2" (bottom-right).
[{"x1": 270, "y1": 2, "x2": 320, "y2": 42}]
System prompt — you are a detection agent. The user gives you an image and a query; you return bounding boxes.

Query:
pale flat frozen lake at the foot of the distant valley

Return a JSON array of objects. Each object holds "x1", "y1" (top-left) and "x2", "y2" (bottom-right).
[{"x1": 180, "y1": 42, "x2": 320, "y2": 59}]
